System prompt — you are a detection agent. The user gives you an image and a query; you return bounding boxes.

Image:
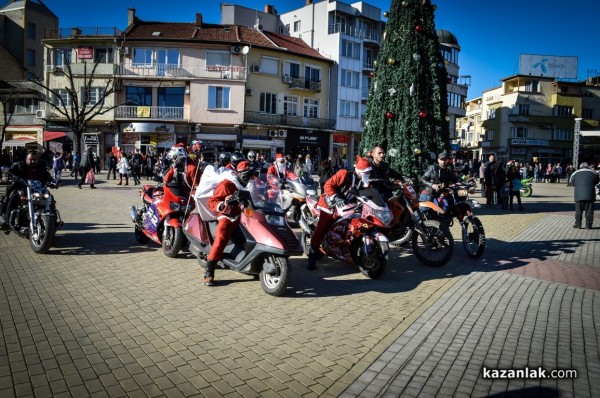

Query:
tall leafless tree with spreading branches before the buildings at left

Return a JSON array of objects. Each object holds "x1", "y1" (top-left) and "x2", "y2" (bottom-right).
[{"x1": 32, "y1": 58, "x2": 119, "y2": 153}]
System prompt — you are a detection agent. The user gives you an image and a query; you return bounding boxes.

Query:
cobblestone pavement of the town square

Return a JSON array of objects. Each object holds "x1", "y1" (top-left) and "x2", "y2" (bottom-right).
[{"x1": 0, "y1": 178, "x2": 600, "y2": 397}]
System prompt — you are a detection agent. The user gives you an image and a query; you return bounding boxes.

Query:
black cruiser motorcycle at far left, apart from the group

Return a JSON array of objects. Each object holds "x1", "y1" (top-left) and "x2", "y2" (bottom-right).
[{"x1": 2, "y1": 168, "x2": 64, "y2": 254}]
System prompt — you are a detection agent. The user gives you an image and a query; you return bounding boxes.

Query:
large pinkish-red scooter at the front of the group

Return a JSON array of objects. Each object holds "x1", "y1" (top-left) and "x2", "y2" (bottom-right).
[{"x1": 183, "y1": 180, "x2": 302, "y2": 296}]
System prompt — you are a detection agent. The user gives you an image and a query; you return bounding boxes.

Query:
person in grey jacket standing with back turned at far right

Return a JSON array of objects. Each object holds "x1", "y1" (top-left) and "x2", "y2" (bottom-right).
[{"x1": 569, "y1": 162, "x2": 600, "y2": 229}]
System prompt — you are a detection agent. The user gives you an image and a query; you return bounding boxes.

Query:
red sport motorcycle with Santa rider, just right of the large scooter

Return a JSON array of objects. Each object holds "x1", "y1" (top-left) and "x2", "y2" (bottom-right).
[{"x1": 300, "y1": 188, "x2": 392, "y2": 279}]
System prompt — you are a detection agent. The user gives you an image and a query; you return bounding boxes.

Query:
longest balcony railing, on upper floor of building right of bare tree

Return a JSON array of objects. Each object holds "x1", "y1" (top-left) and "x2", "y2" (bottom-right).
[{"x1": 115, "y1": 63, "x2": 246, "y2": 80}]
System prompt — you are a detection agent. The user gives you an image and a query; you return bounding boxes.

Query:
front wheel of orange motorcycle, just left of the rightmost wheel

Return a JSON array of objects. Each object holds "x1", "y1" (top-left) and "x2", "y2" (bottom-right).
[{"x1": 412, "y1": 220, "x2": 454, "y2": 267}]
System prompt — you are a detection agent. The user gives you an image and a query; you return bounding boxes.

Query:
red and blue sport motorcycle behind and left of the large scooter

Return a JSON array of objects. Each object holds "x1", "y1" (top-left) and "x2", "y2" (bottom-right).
[{"x1": 130, "y1": 183, "x2": 194, "y2": 258}]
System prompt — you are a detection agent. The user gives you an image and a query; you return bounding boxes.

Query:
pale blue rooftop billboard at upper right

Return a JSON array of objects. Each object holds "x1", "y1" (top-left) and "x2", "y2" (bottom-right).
[{"x1": 519, "y1": 54, "x2": 577, "y2": 79}]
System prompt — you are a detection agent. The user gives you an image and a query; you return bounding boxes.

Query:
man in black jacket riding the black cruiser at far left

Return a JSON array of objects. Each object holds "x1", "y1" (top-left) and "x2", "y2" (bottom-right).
[{"x1": 0, "y1": 151, "x2": 58, "y2": 229}]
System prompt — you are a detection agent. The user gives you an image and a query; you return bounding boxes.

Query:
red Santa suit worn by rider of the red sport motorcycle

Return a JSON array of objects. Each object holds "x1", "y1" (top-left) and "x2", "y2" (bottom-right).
[{"x1": 310, "y1": 169, "x2": 361, "y2": 248}]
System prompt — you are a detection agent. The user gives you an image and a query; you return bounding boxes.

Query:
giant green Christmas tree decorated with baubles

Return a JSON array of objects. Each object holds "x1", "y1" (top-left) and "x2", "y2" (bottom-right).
[{"x1": 360, "y1": 0, "x2": 450, "y2": 177}]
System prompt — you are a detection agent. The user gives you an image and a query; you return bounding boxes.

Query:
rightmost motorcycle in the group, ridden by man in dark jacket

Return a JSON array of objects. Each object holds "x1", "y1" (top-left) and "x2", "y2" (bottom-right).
[{"x1": 434, "y1": 182, "x2": 485, "y2": 258}]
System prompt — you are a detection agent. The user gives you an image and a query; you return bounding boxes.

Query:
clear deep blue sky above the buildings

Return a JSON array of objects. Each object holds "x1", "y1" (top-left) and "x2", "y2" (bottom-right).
[{"x1": 44, "y1": 0, "x2": 600, "y2": 98}]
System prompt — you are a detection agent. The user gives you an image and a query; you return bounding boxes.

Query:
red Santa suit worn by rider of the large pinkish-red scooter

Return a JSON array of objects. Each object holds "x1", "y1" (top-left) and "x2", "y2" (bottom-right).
[{"x1": 208, "y1": 180, "x2": 242, "y2": 261}]
